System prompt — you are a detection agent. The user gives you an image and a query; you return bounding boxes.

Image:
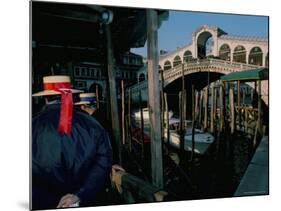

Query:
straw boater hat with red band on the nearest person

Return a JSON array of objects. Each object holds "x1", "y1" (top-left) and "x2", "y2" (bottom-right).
[{"x1": 32, "y1": 75, "x2": 83, "y2": 97}]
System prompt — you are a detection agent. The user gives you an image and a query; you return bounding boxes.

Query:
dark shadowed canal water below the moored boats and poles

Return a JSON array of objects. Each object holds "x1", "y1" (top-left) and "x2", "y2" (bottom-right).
[{"x1": 128, "y1": 117, "x2": 254, "y2": 201}]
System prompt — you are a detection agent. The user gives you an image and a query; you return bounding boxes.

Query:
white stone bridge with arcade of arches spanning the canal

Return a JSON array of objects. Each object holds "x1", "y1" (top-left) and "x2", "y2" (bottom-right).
[{"x1": 130, "y1": 25, "x2": 268, "y2": 104}]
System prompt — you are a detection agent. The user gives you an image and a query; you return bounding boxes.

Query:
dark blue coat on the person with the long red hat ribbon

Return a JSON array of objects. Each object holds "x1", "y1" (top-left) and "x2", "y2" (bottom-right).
[{"x1": 32, "y1": 104, "x2": 112, "y2": 209}]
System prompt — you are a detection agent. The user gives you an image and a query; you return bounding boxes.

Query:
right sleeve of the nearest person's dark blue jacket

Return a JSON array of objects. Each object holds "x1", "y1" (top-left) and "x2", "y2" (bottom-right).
[{"x1": 76, "y1": 131, "x2": 112, "y2": 202}]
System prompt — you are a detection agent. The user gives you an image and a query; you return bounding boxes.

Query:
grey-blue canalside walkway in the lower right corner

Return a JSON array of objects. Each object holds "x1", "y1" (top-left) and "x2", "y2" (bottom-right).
[{"x1": 234, "y1": 136, "x2": 269, "y2": 196}]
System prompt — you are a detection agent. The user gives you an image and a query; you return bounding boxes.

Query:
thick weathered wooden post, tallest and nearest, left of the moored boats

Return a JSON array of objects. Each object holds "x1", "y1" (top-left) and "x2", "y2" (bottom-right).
[{"x1": 146, "y1": 9, "x2": 164, "y2": 188}]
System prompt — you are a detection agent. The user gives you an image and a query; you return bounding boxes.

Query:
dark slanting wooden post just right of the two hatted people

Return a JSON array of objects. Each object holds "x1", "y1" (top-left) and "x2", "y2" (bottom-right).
[{"x1": 105, "y1": 25, "x2": 122, "y2": 165}]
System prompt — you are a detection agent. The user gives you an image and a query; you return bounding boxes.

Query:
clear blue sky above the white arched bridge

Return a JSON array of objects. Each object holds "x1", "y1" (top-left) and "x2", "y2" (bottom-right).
[{"x1": 131, "y1": 10, "x2": 268, "y2": 57}]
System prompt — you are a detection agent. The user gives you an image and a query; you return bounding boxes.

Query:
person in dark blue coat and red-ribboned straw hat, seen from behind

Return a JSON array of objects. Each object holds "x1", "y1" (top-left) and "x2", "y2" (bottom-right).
[{"x1": 32, "y1": 76, "x2": 112, "y2": 209}]
